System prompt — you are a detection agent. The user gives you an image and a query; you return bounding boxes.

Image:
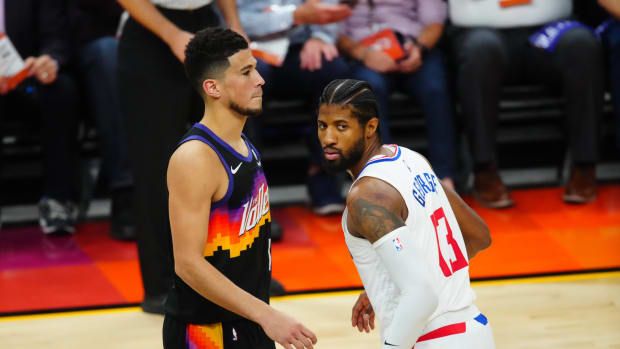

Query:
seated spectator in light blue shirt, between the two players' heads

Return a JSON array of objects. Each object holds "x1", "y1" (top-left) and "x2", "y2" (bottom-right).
[{"x1": 237, "y1": 0, "x2": 351, "y2": 215}]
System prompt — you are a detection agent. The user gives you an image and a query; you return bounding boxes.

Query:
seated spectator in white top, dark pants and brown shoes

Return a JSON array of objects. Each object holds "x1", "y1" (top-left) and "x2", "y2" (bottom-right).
[{"x1": 449, "y1": 0, "x2": 603, "y2": 208}]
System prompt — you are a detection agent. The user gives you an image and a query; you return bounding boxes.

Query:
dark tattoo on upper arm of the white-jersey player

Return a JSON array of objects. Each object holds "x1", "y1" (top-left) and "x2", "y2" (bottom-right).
[{"x1": 350, "y1": 198, "x2": 405, "y2": 243}]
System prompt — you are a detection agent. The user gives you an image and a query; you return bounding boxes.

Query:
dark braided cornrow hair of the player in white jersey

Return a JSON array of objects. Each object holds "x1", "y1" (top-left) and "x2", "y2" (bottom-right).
[{"x1": 319, "y1": 79, "x2": 381, "y2": 140}]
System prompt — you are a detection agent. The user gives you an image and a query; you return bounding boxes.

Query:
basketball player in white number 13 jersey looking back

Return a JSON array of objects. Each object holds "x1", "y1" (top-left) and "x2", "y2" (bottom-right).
[{"x1": 318, "y1": 80, "x2": 495, "y2": 349}]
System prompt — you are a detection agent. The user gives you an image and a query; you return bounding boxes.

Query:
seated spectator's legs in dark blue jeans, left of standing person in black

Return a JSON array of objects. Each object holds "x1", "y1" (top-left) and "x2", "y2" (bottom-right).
[{"x1": 69, "y1": 0, "x2": 136, "y2": 240}]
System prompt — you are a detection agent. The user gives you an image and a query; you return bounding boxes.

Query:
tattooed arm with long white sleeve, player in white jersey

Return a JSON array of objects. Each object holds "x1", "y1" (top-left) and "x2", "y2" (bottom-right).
[{"x1": 347, "y1": 177, "x2": 438, "y2": 347}]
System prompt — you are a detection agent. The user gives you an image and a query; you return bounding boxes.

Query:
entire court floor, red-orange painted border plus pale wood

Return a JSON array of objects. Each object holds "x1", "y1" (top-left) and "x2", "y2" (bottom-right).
[{"x1": 0, "y1": 185, "x2": 620, "y2": 349}]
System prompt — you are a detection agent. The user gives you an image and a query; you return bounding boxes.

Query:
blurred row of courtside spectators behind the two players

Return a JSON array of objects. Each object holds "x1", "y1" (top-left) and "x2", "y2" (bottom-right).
[{"x1": 0, "y1": 0, "x2": 620, "y2": 312}]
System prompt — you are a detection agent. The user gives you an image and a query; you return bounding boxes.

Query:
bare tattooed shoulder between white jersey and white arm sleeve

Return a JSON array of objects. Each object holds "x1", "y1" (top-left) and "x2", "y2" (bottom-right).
[{"x1": 347, "y1": 177, "x2": 407, "y2": 243}]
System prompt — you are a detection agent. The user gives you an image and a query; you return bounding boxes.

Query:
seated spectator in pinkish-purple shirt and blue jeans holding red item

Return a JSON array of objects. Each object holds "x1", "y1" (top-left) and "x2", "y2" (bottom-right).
[{"x1": 339, "y1": 0, "x2": 455, "y2": 188}]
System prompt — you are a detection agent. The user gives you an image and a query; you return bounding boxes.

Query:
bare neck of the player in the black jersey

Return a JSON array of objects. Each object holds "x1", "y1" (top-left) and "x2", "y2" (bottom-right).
[{"x1": 200, "y1": 103, "x2": 247, "y2": 146}]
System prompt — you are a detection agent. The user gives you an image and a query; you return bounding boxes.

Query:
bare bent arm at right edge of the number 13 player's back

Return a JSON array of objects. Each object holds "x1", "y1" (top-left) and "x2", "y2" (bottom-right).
[{"x1": 442, "y1": 179, "x2": 491, "y2": 259}]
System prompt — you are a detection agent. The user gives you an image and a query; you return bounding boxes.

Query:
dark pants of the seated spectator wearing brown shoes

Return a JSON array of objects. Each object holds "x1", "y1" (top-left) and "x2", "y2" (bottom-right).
[{"x1": 452, "y1": 27, "x2": 604, "y2": 165}]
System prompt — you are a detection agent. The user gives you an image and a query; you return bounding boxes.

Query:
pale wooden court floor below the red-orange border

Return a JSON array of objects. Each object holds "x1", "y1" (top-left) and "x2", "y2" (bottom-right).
[{"x1": 0, "y1": 272, "x2": 620, "y2": 349}]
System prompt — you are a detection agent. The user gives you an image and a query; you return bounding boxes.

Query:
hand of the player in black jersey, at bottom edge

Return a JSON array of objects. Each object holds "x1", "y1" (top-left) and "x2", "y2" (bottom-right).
[{"x1": 260, "y1": 308, "x2": 317, "y2": 349}]
